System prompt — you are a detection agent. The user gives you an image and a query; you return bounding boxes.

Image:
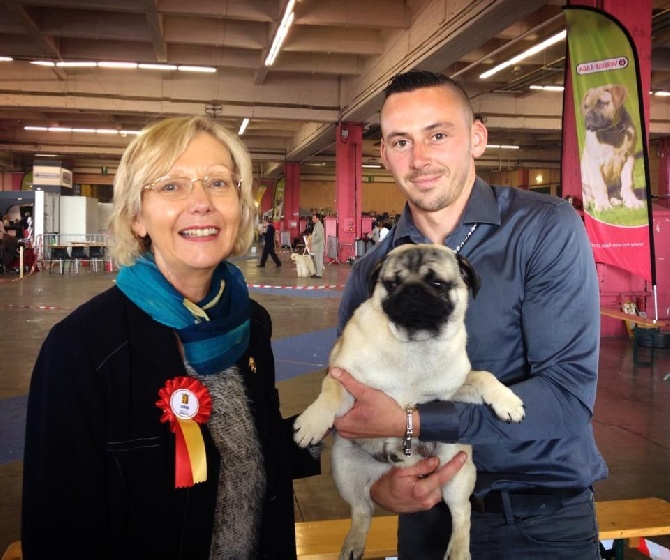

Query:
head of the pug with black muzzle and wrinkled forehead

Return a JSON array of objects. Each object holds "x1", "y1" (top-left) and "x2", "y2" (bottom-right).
[{"x1": 372, "y1": 245, "x2": 478, "y2": 341}]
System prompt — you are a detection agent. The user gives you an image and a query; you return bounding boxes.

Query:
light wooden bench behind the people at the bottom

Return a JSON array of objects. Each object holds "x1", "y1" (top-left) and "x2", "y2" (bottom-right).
[{"x1": 2, "y1": 498, "x2": 670, "y2": 560}]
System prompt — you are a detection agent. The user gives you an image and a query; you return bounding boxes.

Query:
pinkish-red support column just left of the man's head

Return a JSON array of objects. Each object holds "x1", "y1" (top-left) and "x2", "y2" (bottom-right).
[{"x1": 335, "y1": 123, "x2": 363, "y2": 262}]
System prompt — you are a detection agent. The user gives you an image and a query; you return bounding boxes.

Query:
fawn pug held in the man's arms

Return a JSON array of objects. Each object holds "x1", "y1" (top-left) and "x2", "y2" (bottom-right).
[{"x1": 294, "y1": 245, "x2": 525, "y2": 560}]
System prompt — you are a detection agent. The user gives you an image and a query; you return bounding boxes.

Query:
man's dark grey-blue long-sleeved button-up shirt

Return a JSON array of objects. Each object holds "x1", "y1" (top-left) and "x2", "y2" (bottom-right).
[{"x1": 339, "y1": 178, "x2": 607, "y2": 495}]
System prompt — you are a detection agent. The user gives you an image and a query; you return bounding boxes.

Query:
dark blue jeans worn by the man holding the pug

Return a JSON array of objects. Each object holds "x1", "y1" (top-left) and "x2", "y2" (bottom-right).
[{"x1": 398, "y1": 490, "x2": 601, "y2": 560}]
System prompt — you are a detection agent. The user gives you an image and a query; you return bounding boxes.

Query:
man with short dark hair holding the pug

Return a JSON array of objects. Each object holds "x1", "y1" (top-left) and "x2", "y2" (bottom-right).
[{"x1": 331, "y1": 71, "x2": 607, "y2": 560}]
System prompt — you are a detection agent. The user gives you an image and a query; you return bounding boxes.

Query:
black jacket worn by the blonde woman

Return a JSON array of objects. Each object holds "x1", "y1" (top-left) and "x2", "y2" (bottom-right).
[{"x1": 22, "y1": 287, "x2": 319, "y2": 560}]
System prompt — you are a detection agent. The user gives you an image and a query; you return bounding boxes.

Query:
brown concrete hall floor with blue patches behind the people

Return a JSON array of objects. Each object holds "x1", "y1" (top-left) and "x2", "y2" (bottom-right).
[{"x1": 0, "y1": 247, "x2": 670, "y2": 559}]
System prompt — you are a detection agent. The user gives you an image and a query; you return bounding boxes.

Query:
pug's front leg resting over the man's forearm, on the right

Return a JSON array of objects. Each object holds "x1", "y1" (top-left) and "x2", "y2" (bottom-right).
[{"x1": 451, "y1": 370, "x2": 526, "y2": 422}]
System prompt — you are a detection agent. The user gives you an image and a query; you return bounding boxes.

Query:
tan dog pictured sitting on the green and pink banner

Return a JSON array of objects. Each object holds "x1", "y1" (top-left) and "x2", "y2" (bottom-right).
[{"x1": 581, "y1": 85, "x2": 644, "y2": 212}]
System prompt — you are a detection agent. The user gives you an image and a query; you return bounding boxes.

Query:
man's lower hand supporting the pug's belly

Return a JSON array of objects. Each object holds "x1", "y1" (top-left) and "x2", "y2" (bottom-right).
[{"x1": 370, "y1": 451, "x2": 467, "y2": 513}]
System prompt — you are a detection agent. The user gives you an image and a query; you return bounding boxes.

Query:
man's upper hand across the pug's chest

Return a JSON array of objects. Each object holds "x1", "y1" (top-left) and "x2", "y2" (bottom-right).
[{"x1": 329, "y1": 367, "x2": 410, "y2": 438}]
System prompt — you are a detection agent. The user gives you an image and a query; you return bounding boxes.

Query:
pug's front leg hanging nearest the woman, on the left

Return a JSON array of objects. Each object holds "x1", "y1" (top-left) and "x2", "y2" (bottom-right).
[{"x1": 293, "y1": 375, "x2": 354, "y2": 447}]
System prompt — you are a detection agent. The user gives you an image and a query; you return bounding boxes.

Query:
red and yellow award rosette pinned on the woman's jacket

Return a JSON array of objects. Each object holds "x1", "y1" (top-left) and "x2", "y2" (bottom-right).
[{"x1": 156, "y1": 377, "x2": 212, "y2": 488}]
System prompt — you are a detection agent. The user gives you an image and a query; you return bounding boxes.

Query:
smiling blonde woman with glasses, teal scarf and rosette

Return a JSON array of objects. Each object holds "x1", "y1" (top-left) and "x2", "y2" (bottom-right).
[{"x1": 22, "y1": 116, "x2": 319, "y2": 560}]
